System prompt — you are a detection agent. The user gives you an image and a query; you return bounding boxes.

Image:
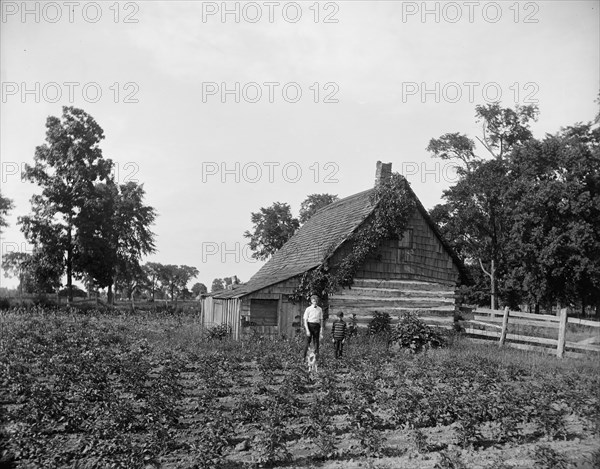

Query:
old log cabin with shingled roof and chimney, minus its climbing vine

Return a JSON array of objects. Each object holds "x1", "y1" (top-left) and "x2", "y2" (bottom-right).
[{"x1": 202, "y1": 162, "x2": 464, "y2": 339}]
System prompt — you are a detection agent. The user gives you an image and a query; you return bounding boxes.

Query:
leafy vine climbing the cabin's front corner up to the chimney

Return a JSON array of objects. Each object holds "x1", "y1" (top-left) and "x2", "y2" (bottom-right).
[{"x1": 289, "y1": 173, "x2": 415, "y2": 303}]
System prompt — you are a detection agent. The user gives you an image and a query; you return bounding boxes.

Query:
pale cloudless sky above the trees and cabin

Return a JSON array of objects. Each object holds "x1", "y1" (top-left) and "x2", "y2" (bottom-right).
[{"x1": 0, "y1": 0, "x2": 600, "y2": 289}]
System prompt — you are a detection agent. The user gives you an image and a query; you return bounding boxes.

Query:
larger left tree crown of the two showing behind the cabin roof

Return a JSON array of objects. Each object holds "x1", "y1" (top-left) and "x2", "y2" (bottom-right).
[{"x1": 244, "y1": 202, "x2": 300, "y2": 260}]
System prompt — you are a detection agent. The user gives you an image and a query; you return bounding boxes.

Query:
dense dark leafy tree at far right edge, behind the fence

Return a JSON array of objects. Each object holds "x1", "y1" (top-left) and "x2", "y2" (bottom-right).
[{"x1": 506, "y1": 123, "x2": 600, "y2": 311}]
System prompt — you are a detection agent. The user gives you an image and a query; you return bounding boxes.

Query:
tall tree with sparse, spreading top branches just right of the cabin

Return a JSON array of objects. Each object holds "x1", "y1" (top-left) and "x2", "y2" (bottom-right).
[{"x1": 427, "y1": 104, "x2": 538, "y2": 308}]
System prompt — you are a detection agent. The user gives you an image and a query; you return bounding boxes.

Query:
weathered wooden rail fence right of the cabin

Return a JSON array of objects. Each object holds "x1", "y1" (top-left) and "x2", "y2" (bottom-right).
[{"x1": 457, "y1": 308, "x2": 600, "y2": 358}]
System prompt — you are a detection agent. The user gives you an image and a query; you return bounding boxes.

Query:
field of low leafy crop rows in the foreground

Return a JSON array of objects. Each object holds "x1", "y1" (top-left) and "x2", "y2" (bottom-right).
[{"x1": 0, "y1": 308, "x2": 600, "y2": 469}]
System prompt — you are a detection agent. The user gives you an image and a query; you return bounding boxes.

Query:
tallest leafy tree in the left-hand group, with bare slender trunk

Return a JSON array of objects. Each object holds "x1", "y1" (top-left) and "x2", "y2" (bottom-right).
[{"x1": 19, "y1": 106, "x2": 112, "y2": 302}]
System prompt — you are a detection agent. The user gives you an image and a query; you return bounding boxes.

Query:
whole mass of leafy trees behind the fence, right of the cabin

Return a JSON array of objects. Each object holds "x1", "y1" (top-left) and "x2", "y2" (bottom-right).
[{"x1": 428, "y1": 100, "x2": 600, "y2": 311}]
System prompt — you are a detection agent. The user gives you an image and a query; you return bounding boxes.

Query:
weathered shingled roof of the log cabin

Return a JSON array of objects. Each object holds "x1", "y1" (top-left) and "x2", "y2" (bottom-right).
[{"x1": 213, "y1": 162, "x2": 467, "y2": 298}]
